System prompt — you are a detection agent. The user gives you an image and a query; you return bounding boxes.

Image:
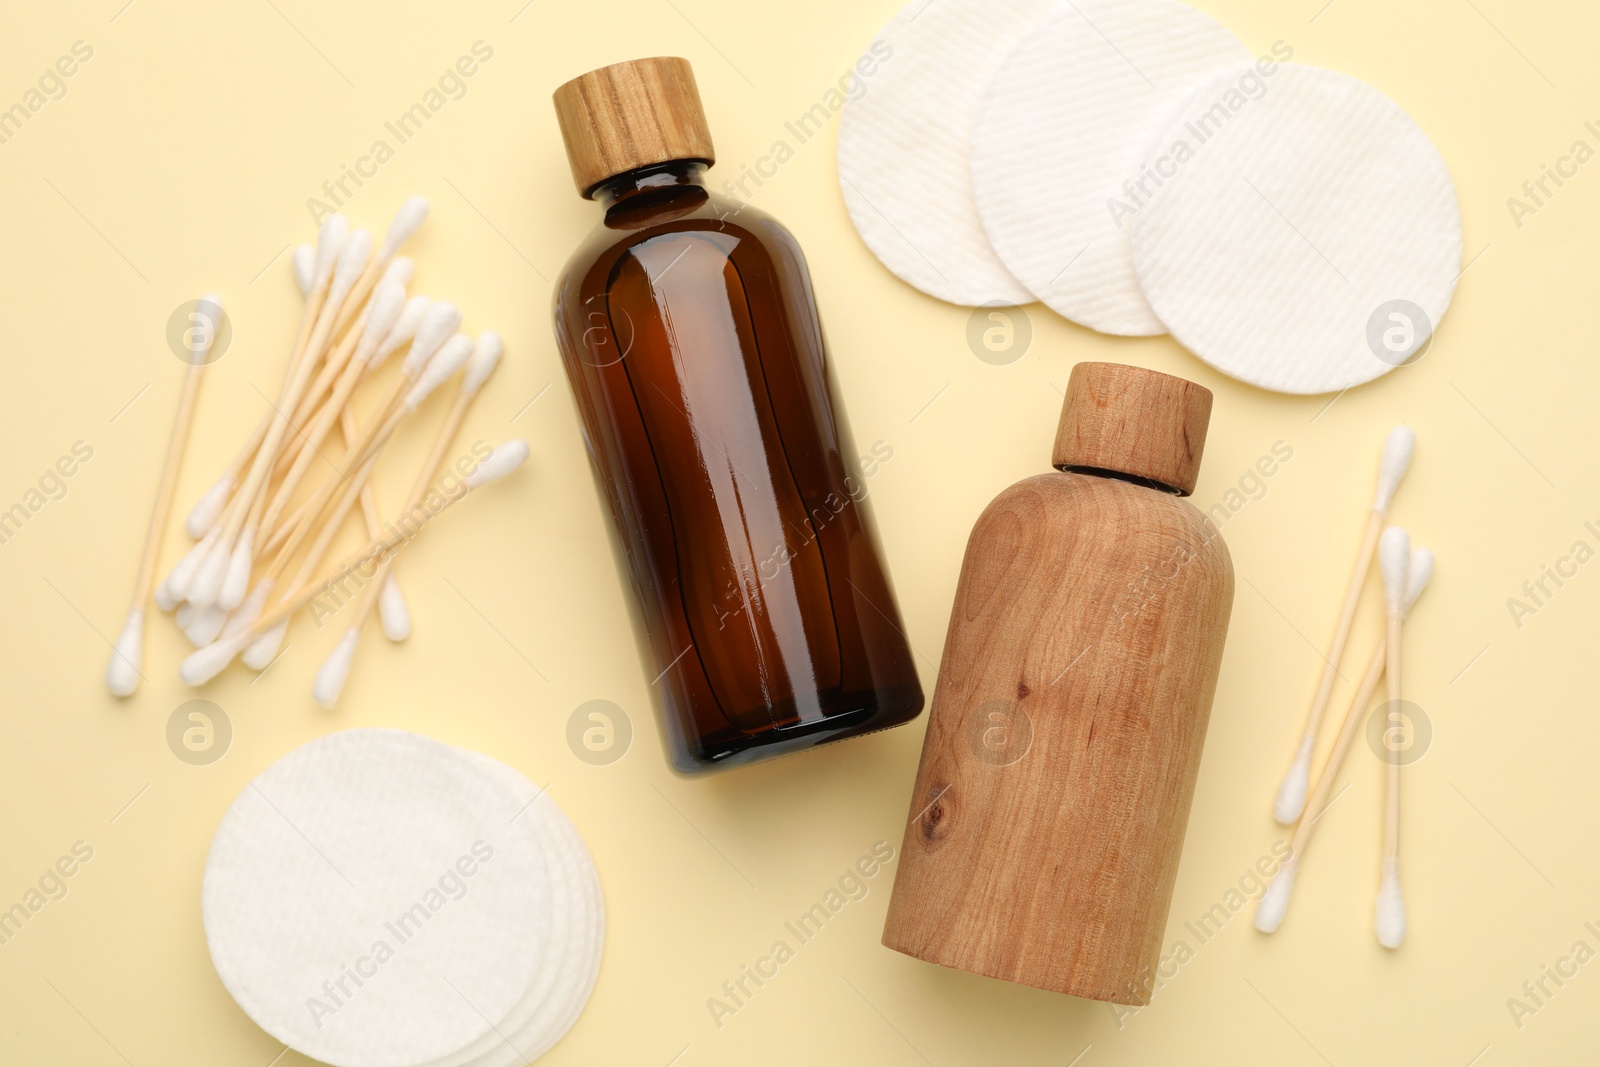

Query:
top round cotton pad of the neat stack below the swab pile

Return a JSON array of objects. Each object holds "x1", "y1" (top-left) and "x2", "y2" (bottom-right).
[{"x1": 202, "y1": 729, "x2": 549, "y2": 1067}]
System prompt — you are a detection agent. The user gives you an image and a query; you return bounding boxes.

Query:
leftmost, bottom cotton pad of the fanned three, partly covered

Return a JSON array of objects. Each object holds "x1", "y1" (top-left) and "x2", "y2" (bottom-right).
[{"x1": 838, "y1": 0, "x2": 1066, "y2": 306}]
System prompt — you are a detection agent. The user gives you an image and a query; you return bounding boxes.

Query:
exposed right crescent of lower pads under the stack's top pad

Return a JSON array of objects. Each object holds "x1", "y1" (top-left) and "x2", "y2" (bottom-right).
[{"x1": 429, "y1": 752, "x2": 605, "y2": 1067}]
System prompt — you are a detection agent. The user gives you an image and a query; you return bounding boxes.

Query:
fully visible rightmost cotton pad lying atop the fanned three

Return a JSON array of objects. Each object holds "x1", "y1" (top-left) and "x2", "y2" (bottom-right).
[{"x1": 1133, "y1": 64, "x2": 1461, "y2": 394}]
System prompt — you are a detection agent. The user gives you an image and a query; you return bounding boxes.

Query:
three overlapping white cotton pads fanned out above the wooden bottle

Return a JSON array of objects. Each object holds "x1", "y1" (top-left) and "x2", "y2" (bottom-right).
[{"x1": 838, "y1": 0, "x2": 1462, "y2": 394}]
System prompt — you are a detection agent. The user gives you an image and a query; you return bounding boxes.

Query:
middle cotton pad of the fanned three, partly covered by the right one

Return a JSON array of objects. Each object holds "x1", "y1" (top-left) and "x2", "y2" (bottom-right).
[{"x1": 971, "y1": 0, "x2": 1250, "y2": 336}]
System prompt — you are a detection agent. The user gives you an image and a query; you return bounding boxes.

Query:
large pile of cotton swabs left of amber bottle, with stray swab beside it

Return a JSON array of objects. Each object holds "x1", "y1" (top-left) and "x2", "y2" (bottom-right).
[{"x1": 106, "y1": 197, "x2": 528, "y2": 707}]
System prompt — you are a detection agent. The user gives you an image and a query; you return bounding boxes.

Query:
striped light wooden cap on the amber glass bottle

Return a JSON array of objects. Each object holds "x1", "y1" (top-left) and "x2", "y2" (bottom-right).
[{"x1": 555, "y1": 56, "x2": 715, "y2": 200}]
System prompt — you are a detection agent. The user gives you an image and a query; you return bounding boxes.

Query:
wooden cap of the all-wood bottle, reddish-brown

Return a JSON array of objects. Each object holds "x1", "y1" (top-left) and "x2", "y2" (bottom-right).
[{"x1": 1051, "y1": 363, "x2": 1211, "y2": 496}]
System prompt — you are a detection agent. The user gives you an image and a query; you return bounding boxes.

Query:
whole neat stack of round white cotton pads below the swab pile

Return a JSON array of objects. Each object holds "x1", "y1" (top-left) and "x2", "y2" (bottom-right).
[{"x1": 202, "y1": 729, "x2": 605, "y2": 1067}]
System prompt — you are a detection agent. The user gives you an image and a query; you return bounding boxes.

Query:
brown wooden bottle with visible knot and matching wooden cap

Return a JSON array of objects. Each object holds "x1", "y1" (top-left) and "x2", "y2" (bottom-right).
[{"x1": 883, "y1": 363, "x2": 1234, "y2": 1005}]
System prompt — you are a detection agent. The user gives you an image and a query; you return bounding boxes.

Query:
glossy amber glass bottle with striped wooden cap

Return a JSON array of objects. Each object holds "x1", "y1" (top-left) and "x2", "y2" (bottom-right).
[{"x1": 555, "y1": 59, "x2": 923, "y2": 773}]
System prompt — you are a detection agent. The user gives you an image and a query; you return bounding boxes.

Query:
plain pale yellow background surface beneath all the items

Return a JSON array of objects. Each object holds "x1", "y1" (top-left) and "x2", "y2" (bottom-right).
[{"x1": 0, "y1": 0, "x2": 1600, "y2": 1067}]
